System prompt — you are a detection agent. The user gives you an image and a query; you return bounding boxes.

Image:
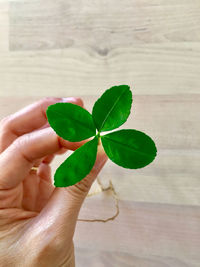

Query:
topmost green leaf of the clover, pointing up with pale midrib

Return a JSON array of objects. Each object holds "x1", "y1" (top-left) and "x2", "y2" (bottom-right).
[{"x1": 92, "y1": 85, "x2": 132, "y2": 132}]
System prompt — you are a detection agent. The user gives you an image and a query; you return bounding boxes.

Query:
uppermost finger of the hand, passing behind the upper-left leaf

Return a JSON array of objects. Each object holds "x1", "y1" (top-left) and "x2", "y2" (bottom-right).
[{"x1": 0, "y1": 97, "x2": 83, "y2": 153}]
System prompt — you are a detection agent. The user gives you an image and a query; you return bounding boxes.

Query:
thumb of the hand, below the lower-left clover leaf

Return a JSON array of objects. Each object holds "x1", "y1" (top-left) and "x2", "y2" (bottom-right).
[{"x1": 33, "y1": 144, "x2": 108, "y2": 243}]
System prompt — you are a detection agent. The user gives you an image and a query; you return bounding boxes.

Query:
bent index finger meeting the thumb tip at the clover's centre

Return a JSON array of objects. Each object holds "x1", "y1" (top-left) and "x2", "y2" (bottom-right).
[{"x1": 0, "y1": 127, "x2": 89, "y2": 189}]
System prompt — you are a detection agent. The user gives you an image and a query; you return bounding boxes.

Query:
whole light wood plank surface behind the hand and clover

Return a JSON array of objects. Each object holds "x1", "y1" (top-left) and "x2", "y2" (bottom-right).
[{"x1": 0, "y1": 0, "x2": 200, "y2": 267}]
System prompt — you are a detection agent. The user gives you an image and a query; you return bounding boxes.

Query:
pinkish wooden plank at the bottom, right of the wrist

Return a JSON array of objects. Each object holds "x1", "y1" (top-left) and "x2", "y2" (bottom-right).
[{"x1": 74, "y1": 199, "x2": 200, "y2": 267}]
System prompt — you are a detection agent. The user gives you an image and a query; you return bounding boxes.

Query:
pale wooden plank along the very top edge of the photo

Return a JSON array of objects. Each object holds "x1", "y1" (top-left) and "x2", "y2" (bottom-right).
[{"x1": 10, "y1": 0, "x2": 200, "y2": 50}]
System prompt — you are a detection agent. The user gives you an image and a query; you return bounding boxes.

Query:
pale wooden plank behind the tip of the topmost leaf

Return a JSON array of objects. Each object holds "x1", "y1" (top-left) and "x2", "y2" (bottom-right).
[{"x1": 0, "y1": 43, "x2": 200, "y2": 97}]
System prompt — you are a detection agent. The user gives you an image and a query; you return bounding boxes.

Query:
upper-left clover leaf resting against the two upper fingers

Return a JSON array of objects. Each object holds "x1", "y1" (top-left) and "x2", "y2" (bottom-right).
[{"x1": 46, "y1": 103, "x2": 96, "y2": 142}]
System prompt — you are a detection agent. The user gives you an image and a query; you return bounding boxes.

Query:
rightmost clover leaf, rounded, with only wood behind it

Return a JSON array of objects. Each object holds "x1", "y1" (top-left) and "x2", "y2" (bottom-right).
[{"x1": 101, "y1": 129, "x2": 157, "y2": 169}]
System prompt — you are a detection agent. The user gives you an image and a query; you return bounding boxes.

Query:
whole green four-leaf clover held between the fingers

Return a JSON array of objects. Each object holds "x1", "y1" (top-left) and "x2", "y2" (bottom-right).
[{"x1": 46, "y1": 85, "x2": 157, "y2": 187}]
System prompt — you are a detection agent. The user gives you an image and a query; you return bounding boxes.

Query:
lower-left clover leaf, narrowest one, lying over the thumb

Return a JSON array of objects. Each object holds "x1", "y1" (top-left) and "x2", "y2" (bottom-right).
[{"x1": 54, "y1": 136, "x2": 98, "y2": 187}]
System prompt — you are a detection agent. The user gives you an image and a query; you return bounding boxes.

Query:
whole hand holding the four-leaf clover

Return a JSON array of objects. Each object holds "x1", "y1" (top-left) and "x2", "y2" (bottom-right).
[{"x1": 0, "y1": 98, "x2": 107, "y2": 267}]
